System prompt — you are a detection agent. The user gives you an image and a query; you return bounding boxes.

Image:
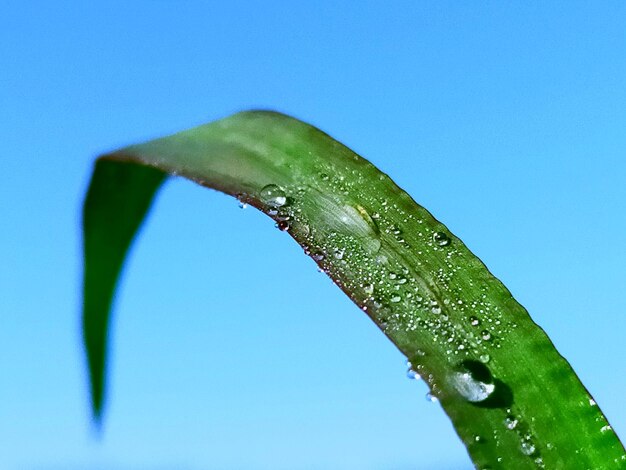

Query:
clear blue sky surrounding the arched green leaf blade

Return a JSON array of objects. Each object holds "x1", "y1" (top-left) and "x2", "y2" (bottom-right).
[{"x1": 0, "y1": 1, "x2": 626, "y2": 470}]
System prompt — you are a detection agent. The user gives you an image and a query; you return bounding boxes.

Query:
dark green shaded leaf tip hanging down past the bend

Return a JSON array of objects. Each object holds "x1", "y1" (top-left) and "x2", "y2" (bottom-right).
[{"x1": 83, "y1": 160, "x2": 166, "y2": 422}]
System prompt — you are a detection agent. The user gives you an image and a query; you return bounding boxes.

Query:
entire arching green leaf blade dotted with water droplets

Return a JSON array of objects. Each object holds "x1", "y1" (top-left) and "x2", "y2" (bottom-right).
[{"x1": 85, "y1": 111, "x2": 626, "y2": 470}]
